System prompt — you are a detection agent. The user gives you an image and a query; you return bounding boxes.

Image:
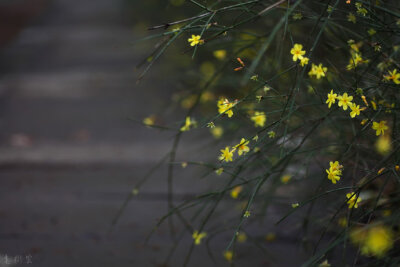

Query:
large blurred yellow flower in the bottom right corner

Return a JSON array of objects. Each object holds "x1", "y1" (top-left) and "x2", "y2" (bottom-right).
[{"x1": 361, "y1": 225, "x2": 394, "y2": 258}]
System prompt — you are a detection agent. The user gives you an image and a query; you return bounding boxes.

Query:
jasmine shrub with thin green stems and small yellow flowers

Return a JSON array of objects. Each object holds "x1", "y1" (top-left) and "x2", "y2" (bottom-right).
[{"x1": 128, "y1": 0, "x2": 400, "y2": 266}]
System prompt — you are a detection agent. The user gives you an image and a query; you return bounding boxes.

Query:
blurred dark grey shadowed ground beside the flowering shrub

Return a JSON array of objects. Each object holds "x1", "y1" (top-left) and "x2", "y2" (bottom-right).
[{"x1": 0, "y1": 0, "x2": 312, "y2": 267}]
